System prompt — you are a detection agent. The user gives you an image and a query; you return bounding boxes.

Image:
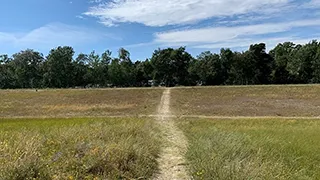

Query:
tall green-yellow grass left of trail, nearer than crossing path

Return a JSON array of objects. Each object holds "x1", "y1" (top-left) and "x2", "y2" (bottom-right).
[{"x1": 0, "y1": 118, "x2": 161, "y2": 180}]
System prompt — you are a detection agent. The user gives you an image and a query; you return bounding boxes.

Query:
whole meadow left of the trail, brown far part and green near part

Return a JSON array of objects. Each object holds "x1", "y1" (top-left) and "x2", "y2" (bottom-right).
[{"x1": 0, "y1": 88, "x2": 163, "y2": 180}]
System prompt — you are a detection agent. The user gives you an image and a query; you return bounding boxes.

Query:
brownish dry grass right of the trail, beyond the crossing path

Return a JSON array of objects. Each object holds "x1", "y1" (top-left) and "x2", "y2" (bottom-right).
[{"x1": 171, "y1": 85, "x2": 320, "y2": 117}]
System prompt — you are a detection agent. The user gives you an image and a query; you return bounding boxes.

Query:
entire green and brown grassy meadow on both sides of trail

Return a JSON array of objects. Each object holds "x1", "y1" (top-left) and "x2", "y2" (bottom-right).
[{"x1": 0, "y1": 85, "x2": 320, "y2": 180}]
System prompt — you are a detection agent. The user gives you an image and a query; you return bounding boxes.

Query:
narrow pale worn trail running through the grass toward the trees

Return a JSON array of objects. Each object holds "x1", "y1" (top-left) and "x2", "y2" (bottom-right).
[{"x1": 155, "y1": 89, "x2": 190, "y2": 180}]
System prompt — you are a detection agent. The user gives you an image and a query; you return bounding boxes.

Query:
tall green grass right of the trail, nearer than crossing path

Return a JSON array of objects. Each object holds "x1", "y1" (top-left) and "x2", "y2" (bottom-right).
[{"x1": 178, "y1": 119, "x2": 320, "y2": 180}]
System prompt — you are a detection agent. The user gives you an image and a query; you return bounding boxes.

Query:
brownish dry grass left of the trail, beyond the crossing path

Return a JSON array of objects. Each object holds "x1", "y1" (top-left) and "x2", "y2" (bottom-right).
[{"x1": 0, "y1": 88, "x2": 163, "y2": 118}]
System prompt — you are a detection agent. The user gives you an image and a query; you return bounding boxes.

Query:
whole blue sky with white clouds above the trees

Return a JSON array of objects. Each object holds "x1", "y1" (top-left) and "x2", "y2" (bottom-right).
[{"x1": 0, "y1": 0, "x2": 320, "y2": 60}]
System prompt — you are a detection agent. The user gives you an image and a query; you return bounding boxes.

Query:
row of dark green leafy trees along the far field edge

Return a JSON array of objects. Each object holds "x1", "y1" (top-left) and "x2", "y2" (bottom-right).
[{"x1": 0, "y1": 40, "x2": 320, "y2": 89}]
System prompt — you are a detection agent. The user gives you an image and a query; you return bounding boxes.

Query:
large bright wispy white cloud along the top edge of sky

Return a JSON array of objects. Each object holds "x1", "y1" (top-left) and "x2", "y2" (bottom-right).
[{"x1": 85, "y1": 0, "x2": 290, "y2": 26}]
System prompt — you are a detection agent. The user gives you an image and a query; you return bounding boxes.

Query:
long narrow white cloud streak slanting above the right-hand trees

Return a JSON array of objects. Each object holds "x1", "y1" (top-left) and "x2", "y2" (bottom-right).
[{"x1": 155, "y1": 19, "x2": 320, "y2": 45}]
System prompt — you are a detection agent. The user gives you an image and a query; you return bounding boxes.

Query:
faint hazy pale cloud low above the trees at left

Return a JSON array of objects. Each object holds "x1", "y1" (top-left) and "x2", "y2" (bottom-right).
[{"x1": 0, "y1": 23, "x2": 111, "y2": 50}]
